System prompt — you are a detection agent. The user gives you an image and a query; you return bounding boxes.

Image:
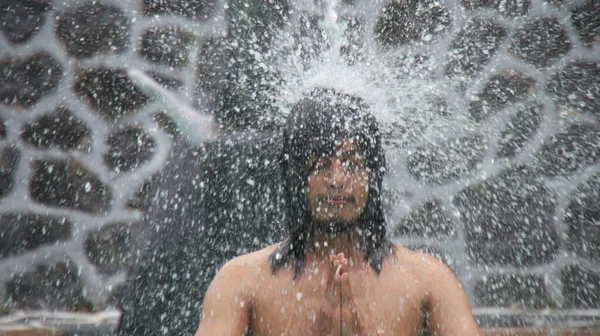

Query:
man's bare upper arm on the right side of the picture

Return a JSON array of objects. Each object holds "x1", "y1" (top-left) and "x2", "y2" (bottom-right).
[{"x1": 426, "y1": 257, "x2": 481, "y2": 336}]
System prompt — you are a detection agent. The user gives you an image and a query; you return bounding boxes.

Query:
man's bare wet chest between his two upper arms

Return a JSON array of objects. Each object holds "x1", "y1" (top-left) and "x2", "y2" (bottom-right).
[{"x1": 251, "y1": 274, "x2": 424, "y2": 336}]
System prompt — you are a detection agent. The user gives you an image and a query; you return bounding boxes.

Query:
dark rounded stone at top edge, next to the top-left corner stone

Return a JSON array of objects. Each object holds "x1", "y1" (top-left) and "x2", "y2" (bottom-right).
[{"x1": 56, "y1": 3, "x2": 131, "y2": 58}]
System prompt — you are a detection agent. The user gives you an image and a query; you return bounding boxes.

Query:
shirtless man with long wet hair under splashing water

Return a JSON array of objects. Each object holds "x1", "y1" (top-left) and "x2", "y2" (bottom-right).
[{"x1": 196, "y1": 89, "x2": 480, "y2": 336}]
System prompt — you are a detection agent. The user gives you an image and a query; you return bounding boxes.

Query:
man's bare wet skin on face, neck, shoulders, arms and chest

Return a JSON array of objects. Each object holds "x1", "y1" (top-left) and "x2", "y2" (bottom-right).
[{"x1": 196, "y1": 139, "x2": 480, "y2": 336}]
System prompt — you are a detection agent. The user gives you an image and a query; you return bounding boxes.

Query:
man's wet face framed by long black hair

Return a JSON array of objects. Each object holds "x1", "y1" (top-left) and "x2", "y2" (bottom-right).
[{"x1": 306, "y1": 139, "x2": 369, "y2": 229}]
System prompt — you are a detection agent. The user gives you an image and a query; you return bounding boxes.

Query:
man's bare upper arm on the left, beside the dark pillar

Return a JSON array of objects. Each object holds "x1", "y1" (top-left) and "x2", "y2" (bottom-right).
[{"x1": 196, "y1": 259, "x2": 252, "y2": 336}]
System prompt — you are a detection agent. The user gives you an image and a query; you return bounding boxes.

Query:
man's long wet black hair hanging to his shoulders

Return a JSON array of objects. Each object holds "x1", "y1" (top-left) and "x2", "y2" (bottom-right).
[{"x1": 270, "y1": 88, "x2": 392, "y2": 278}]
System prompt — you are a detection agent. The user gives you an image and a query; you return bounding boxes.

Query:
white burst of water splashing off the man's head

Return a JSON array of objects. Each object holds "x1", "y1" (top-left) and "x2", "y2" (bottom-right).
[{"x1": 273, "y1": 0, "x2": 471, "y2": 155}]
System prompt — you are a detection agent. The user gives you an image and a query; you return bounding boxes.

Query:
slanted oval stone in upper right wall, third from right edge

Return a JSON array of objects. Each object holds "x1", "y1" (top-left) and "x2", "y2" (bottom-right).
[{"x1": 445, "y1": 19, "x2": 507, "y2": 77}]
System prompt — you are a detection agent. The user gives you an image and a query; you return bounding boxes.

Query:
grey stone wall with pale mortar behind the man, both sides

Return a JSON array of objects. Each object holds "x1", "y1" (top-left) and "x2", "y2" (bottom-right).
[{"x1": 0, "y1": 0, "x2": 600, "y2": 318}]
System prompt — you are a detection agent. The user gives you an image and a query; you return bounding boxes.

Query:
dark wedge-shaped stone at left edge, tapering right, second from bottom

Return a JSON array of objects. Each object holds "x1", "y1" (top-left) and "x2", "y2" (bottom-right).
[{"x1": 0, "y1": 213, "x2": 73, "y2": 259}]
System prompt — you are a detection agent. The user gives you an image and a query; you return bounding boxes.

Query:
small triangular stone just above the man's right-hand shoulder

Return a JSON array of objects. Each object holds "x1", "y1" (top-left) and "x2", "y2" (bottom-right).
[{"x1": 393, "y1": 199, "x2": 456, "y2": 238}]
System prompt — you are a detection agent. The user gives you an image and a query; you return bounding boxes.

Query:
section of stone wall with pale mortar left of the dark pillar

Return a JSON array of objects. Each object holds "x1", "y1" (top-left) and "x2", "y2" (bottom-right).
[{"x1": 0, "y1": 0, "x2": 223, "y2": 311}]
